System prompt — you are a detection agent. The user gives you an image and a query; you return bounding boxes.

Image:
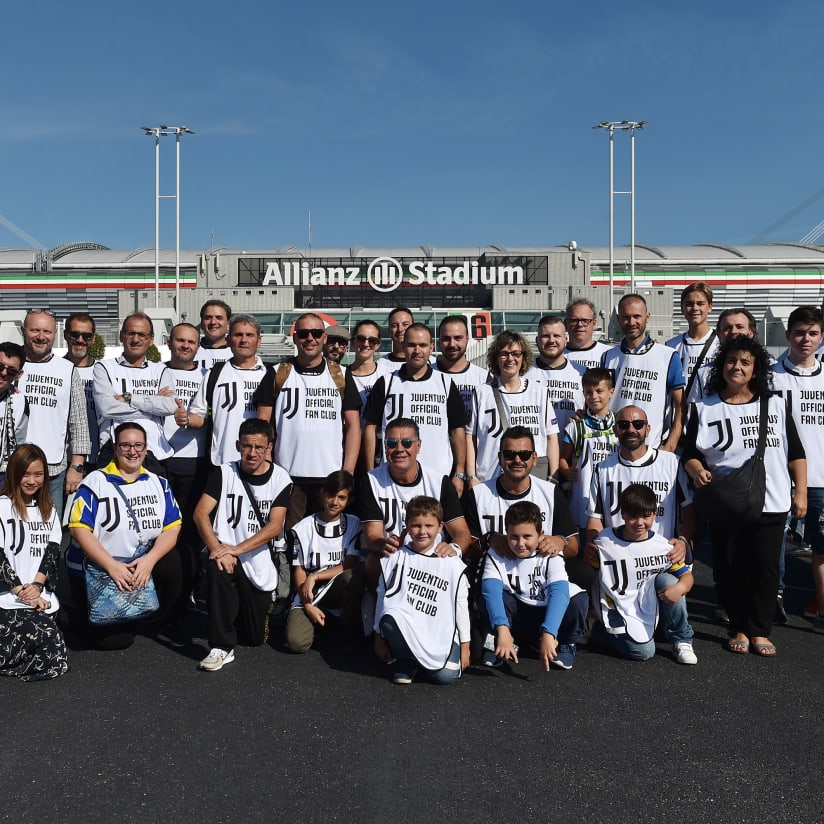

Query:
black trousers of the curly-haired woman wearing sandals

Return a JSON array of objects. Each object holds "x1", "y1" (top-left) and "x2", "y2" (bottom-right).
[{"x1": 710, "y1": 514, "x2": 786, "y2": 638}]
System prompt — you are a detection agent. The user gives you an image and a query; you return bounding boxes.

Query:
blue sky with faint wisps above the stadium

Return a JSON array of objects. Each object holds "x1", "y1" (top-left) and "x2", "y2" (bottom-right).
[{"x1": 0, "y1": 0, "x2": 824, "y2": 249}]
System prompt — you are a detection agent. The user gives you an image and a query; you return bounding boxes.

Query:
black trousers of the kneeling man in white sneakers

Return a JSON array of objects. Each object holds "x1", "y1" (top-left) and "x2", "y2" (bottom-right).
[{"x1": 206, "y1": 561, "x2": 272, "y2": 652}]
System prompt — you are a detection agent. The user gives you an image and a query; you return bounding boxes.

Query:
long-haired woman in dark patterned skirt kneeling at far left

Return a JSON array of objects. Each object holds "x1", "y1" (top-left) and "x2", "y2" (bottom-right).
[{"x1": 0, "y1": 443, "x2": 69, "y2": 681}]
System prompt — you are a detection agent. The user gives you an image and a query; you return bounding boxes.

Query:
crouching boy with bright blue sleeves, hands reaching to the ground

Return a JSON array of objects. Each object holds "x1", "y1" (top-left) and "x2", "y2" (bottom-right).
[{"x1": 481, "y1": 501, "x2": 587, "y2": 672}]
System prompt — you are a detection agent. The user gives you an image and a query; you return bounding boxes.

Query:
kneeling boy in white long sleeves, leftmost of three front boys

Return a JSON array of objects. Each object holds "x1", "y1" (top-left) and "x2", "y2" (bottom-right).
[{"x1": 375, "y1": 495, "x2": 469, "y2": 684}]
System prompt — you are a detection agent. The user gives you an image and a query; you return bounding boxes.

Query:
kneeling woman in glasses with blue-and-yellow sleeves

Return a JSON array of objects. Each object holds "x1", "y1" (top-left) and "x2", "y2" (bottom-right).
[{"x1": 69, "y1": 421, "x2": 182, "y2": 649}]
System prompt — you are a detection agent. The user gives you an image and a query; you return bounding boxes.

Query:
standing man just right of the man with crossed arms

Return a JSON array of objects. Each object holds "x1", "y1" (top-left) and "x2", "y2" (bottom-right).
[{"x1": 163, "y1": 323, "x2": 211, "y2": 632}]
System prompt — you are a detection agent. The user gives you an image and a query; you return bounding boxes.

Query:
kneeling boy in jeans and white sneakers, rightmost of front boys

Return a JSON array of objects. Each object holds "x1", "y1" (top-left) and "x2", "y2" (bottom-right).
[{"x1": 592, "y1": 484, "x2": 698, "y2": 664}]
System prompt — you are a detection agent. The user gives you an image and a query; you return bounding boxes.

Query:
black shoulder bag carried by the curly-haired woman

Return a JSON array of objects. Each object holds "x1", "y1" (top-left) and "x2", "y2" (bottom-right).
[{"x1": 693, "y1": 395, "x2": 769, "y2": 526}]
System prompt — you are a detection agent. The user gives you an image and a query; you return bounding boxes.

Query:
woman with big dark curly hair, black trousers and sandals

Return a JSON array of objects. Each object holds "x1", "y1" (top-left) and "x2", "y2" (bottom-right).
[{"x1": 684, "y1": 336, "x2": 807, "y2": 657}]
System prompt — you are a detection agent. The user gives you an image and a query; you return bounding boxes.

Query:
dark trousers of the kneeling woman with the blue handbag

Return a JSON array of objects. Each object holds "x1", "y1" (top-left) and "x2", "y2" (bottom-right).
[{"x1": 69, "y1": 549, "x2": 182, "y2": 650}]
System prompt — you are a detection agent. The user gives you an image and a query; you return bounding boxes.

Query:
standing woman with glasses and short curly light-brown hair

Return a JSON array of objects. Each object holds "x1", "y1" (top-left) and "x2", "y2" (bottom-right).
[{"x1": 466, "y1": 331, "x2": 558, "y2": 485}]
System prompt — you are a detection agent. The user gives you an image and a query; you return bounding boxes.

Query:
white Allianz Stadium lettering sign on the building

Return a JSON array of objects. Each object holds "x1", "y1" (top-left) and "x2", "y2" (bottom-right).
[{"x1": 260, "y1": 256, "x2": 527, "y2": 292}]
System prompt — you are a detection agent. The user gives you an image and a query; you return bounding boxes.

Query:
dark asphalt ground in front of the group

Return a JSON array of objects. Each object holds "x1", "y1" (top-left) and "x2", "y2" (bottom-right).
[{"x1": 6, "y1": 540, "x2": 824, "y2": 823}]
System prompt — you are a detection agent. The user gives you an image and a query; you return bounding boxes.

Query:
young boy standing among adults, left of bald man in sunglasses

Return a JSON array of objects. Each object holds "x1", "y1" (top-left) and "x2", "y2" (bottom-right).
[{"x1": 560, "y1": 368, "x2": 618, "y2": 546}]
